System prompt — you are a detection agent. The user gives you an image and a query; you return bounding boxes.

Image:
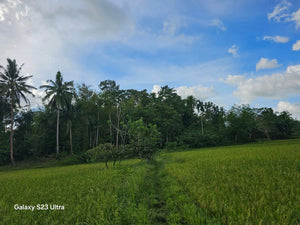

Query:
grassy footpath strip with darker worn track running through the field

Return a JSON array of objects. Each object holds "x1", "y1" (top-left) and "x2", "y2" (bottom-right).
[{"x1": 141, "y1": 160, "x2": 220, "y2": 225}]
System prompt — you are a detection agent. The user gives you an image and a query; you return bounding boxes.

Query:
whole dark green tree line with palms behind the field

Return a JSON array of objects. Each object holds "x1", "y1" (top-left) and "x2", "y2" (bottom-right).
[{"x1": 0, "y1": 59, "x2": 300, "y2": 165}]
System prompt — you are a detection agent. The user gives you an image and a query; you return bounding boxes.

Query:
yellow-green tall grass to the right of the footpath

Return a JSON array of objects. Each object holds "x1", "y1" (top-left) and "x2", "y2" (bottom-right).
[{"x1": 165, "y1": 141, "x2": 300, "y2": 224}]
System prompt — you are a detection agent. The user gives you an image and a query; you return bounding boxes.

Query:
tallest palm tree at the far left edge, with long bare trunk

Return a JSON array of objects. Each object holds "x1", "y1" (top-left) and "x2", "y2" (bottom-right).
[{"x1": 0, "y1": 58, "x2": 36, "y2": 166}]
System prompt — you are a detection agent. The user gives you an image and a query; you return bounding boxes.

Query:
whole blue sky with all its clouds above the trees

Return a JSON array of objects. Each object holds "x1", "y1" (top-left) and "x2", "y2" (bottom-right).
[{"x1": 0, "y1": 0, "x2": 300, "y2": 119}]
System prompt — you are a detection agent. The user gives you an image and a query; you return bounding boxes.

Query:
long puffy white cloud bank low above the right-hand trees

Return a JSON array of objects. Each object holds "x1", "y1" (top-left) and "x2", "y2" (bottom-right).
[{"x1": 224, "y1": 65, "x2": 300, "y2": 103}]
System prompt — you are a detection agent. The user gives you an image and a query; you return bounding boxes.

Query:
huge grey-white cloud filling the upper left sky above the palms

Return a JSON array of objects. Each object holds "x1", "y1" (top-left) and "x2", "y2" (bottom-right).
[{"x1": 0, "y1": 0, "x2": 134, "y2": 92}]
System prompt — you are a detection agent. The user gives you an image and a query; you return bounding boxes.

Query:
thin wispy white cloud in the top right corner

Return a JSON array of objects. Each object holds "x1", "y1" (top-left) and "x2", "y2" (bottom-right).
[{"x1": 268, "y1": 0, "x2": 300, "y2": 29}]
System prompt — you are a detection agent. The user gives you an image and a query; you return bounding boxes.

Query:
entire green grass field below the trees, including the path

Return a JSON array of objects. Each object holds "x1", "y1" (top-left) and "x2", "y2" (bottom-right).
[{"x1": 0, "y1": 140, "x2": 300, "y2": 225}]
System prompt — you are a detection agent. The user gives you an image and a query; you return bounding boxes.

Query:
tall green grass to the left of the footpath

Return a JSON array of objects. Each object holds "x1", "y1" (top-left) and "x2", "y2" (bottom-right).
[{"x1": 0, "y1": 160, "x2": 148, "y2": 224}]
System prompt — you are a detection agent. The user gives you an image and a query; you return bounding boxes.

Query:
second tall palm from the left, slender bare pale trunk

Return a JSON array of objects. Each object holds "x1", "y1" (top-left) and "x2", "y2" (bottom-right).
[{"x1": 40, "y1": 71, "x2": 74, "y2": 157}]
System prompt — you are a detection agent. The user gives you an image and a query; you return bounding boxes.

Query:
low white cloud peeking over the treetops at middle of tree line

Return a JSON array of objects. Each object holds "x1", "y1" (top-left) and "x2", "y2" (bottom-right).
[{"x1": 151, "y1": 84, "x2": 217, "y2": 100}]
